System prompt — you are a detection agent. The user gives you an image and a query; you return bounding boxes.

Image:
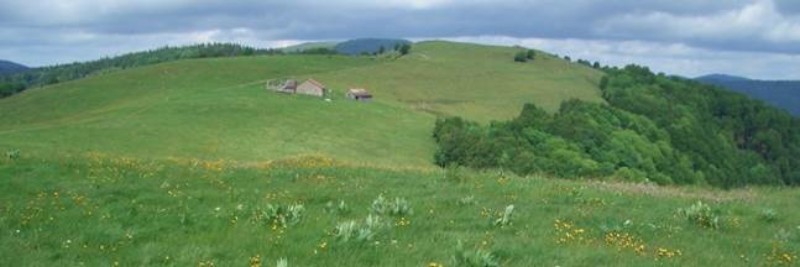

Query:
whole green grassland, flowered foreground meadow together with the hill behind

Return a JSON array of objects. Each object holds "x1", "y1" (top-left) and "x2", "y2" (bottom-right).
[{"x1": 0, "y1": 41, "x2": 800, "y2": 267}]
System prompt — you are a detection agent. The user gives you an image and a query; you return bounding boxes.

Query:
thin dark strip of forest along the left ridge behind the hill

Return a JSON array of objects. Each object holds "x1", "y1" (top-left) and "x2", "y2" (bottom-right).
[{"x1": 0, "y1": 43, "x2": 282, "y2": 98}]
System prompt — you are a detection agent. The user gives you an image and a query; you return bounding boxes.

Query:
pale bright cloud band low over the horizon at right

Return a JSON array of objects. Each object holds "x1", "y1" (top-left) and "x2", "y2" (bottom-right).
[{"x1": 444, "y1": 36, "x2": 800, "y2": 80}]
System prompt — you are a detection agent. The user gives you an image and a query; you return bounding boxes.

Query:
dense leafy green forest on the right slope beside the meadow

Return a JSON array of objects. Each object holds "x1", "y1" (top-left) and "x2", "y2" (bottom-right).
[{"x1": 433, "y1": 65, "x2": 800, "y2": 188}]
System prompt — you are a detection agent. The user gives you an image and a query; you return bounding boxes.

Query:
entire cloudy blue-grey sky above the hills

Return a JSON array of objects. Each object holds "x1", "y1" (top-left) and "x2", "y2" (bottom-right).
[{"x1": 0, "y1": 0, "x2": 800, "y2": 80}]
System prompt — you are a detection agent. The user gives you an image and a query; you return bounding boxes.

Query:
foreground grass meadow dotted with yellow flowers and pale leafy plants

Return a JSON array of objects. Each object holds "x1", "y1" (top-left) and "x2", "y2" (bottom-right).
[{"x1": 0, "y1": 154, "x2": 800, "y2": 266}]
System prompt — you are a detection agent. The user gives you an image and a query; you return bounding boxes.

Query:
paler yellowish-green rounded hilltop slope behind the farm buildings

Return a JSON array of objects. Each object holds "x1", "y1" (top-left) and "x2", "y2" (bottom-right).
[{"x1": 320, "y1": 41, "x2": 603, "y2": 122}]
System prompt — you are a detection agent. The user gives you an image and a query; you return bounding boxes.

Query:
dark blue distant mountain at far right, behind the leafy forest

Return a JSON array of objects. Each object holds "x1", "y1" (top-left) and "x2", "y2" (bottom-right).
[{"x1": 695, "y1": 74, "x2": 800, "y2": 116}]
